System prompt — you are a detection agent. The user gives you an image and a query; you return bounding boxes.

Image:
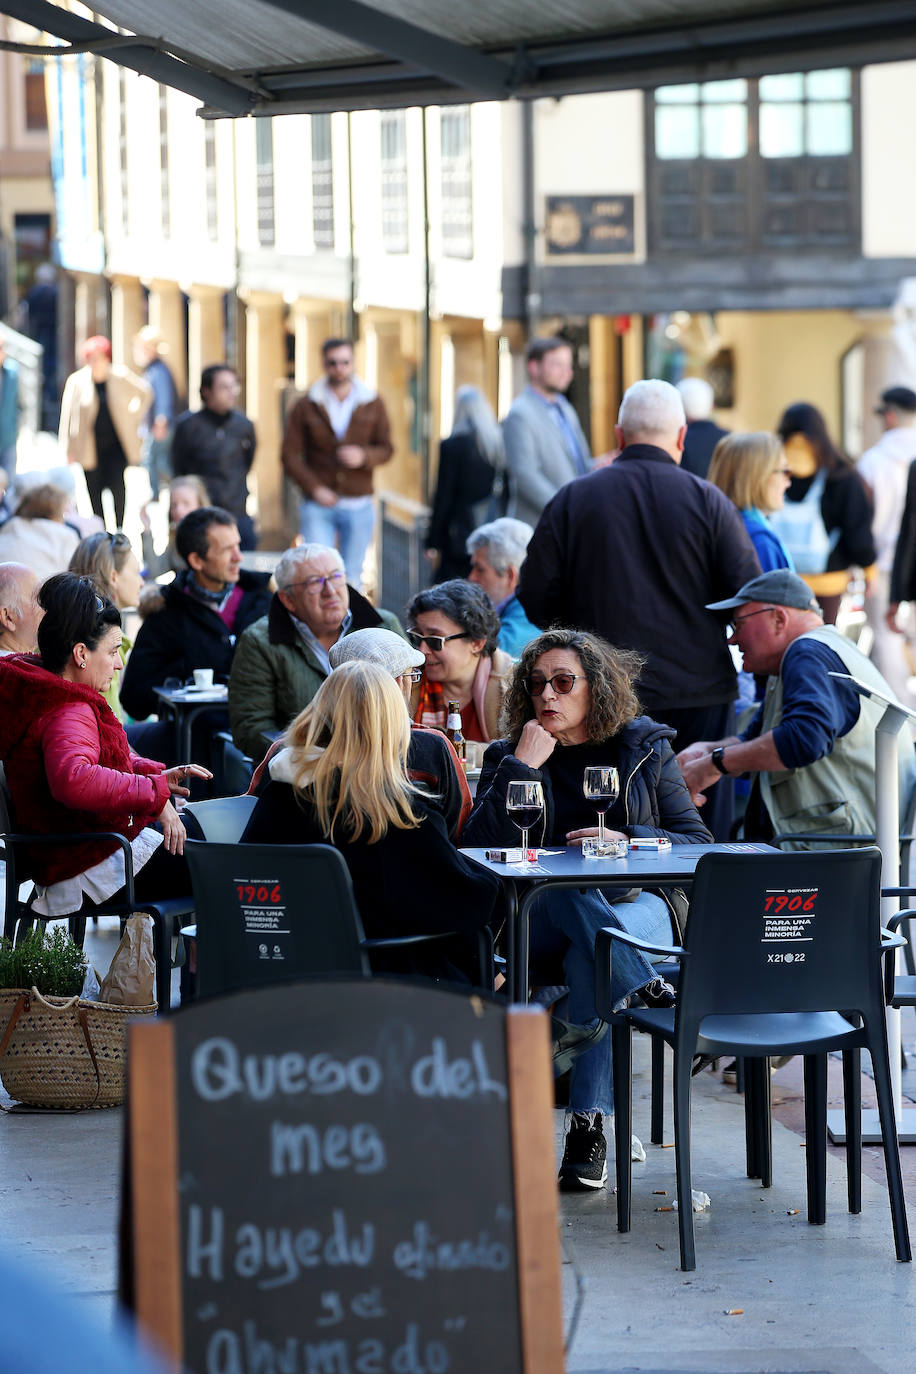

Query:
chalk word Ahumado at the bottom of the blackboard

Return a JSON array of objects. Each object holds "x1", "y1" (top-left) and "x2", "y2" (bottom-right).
[{"x1": 206, "y1": 1322, "x2": 452, "y2": 1374}]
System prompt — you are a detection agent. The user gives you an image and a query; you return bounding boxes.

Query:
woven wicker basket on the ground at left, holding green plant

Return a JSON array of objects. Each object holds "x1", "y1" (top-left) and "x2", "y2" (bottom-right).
[{"x1": 0, "y1": 988, "x2": 157, "y2": 1110}]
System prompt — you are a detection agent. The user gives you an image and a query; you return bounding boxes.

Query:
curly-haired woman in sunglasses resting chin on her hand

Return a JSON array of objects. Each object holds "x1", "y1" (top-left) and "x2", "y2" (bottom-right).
[{"x1": 461, "y1": 629, "x2": 711, "y2": 1190}]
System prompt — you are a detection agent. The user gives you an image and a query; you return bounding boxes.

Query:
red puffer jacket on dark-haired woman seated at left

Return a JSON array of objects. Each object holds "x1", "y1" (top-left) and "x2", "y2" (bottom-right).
[{"x1": 0, "y1": 654, "x2": 170, "y2": 886}]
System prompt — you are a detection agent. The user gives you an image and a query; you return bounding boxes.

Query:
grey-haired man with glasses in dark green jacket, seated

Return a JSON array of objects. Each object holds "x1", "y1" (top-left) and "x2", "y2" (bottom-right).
[{"x1": 229, "y1": 544, "x2": 404, "y2": 758}]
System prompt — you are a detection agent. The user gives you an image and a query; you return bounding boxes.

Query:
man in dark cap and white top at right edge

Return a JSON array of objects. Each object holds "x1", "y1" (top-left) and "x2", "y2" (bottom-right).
[{"x1": 856, "y1": 386, "x2": 916, "y2": 706}]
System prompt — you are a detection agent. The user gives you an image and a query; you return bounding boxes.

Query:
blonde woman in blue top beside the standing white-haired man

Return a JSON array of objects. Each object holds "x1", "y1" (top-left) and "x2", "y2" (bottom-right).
[{"x1": 709, "y1": 431, "x2": 795, "y2": 573}]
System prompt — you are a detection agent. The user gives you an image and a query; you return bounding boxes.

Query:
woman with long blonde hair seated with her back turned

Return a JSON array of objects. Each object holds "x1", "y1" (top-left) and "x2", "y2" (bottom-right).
[{"x1": 242, "y1": 661, "x2": 499, "y2": 973}]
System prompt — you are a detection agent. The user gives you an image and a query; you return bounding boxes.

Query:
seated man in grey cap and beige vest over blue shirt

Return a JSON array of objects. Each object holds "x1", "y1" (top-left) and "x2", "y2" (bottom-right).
[{"x1": 677, "y1": 567, "x2": 916, "y2": 849}]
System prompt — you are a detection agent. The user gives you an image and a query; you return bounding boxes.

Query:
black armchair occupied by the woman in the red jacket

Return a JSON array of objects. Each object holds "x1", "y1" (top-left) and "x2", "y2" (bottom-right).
[{"x1": 0, "y1": 767, "x2": 194, "y2": 1011}]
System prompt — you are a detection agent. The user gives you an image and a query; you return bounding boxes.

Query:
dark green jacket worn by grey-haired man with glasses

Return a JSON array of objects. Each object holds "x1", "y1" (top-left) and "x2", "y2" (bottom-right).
[{"x1": 229, "y1": 587, "x2": 404, "y2": 760}]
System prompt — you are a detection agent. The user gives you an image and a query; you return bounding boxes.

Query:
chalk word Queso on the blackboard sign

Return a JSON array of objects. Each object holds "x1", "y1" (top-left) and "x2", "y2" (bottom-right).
[{"x1": 191, "y1": 1036, "x2": 382, "y2": 1102}]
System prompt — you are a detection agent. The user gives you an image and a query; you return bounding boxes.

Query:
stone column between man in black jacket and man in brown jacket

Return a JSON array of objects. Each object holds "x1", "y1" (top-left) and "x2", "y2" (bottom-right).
[{"x1": 243, "y1": 291, "x2": 291, "y2": 550}]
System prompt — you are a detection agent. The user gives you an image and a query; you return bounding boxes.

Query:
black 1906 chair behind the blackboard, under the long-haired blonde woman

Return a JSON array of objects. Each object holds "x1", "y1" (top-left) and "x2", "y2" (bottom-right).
[{"x1": 184, "y1": 840, "x2": 493, "y2": 996}]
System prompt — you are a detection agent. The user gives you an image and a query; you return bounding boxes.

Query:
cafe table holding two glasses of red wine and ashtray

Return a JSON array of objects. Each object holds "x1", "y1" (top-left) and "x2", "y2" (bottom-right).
[{"x1": 461, "y1": 842, "x2": 773, "y2": 1002}]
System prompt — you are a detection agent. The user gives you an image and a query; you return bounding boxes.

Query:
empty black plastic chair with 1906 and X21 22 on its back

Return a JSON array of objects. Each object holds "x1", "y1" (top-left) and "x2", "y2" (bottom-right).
[{"x1": 596, "y1": 849, "x2": 912, "y2": 1270}]
